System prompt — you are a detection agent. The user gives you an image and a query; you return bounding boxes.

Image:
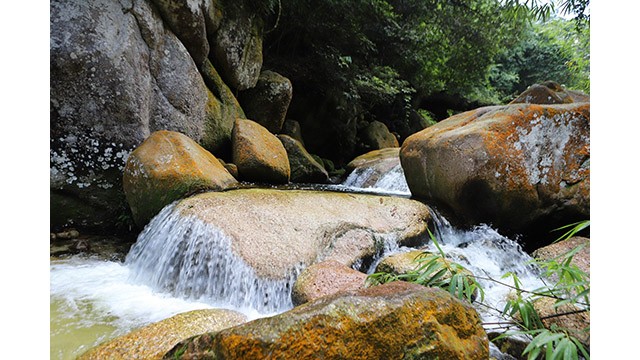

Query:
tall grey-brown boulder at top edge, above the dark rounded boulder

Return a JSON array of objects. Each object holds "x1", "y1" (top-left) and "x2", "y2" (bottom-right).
[{"x1": 209, "y1": 1, "x2": 263, "y2": 91}]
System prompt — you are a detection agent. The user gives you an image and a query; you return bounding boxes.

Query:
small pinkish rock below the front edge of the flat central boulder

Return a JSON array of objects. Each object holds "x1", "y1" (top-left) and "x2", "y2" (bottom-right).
[{"x1": 291, "y1": 260, "x2": 367, "y2": 305}]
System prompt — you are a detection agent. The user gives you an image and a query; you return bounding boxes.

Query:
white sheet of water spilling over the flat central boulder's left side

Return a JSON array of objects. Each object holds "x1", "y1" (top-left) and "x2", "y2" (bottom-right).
[{"x1": 125, "y1": 205, "x2": 302, "y2": 314}]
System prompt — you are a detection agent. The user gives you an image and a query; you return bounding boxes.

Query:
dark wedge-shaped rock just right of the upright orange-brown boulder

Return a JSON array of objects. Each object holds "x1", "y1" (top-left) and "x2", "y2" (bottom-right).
[{"x1": 277, "y1": 135, "x2": 329, "y2": 184}]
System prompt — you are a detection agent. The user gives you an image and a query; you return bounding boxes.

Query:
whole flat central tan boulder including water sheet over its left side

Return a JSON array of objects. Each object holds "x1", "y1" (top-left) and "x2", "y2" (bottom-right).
[{"x1": 127, "y1": 188, "x2": 430, "y2": 313}]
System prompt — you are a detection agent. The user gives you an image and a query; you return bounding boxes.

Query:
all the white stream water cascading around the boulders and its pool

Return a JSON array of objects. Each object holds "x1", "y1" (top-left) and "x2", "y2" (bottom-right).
[{"x1": 50, "y1": 164, "x2": 541, "y2": 360}]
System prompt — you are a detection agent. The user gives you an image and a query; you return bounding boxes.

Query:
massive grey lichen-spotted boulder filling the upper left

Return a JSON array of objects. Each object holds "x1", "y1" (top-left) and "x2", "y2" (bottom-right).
[{"x1": 49, "y1": 0, "x2": 244, "y2": 230}]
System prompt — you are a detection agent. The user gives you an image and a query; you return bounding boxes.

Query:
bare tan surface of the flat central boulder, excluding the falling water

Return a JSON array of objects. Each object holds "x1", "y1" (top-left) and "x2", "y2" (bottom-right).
[{"x1": 176, "y1": 189, "x2": 429, "y2": 279}]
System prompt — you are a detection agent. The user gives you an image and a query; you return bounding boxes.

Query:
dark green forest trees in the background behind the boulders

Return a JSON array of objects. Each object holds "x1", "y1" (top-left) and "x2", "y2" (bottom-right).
[{"x1": 255, "y1": 0, "x2": 589, "y2": 165}]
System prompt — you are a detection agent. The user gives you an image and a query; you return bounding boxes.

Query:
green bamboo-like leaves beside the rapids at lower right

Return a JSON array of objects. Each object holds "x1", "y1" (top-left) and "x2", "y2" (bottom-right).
[{"x1": 367, "y1": 220, "x2": 590, "y2": 360}]
